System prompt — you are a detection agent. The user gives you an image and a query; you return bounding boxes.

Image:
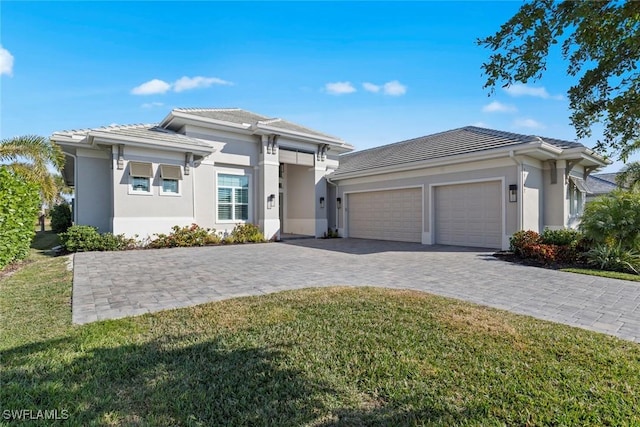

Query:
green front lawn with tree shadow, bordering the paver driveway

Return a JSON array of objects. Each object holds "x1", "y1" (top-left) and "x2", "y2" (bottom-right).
[{"x1": 0, "y1": 236, "x2": 640, "y2": 426}]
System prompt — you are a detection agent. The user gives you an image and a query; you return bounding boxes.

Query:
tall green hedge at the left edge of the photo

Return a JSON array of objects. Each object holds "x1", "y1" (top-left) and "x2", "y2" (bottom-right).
[{"x1": 0, "y1": 167, "x2": 40, "y2": 269}]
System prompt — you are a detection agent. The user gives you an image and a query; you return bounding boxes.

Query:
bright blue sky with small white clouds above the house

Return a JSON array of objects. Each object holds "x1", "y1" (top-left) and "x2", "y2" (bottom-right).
[{"x1": 0, "y1": 1, "x2": 639, "y2": 171}]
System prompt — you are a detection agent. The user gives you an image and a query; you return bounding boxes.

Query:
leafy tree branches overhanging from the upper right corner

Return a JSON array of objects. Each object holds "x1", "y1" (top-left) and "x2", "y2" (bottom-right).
[{"x1": 477, "y1": 0, "x2": 640, "y2": 160}]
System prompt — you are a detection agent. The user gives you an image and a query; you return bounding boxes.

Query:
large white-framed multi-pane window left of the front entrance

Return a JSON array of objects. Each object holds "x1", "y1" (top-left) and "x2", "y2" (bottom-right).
[{"x1": 218, "y1": 174, "x2": 249, "y2": 221}]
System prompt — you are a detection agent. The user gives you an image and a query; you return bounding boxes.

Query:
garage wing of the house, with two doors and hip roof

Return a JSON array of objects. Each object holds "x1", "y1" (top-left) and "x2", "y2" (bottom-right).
[{"x1": 327, "y1": 126, "x2": 609, "y2": 249}]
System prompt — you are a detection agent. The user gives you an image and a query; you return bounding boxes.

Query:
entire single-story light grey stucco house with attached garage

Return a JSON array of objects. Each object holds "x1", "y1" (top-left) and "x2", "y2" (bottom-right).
[{"x1": 51, "y1": 108, "x2": 607, "y2": 249}]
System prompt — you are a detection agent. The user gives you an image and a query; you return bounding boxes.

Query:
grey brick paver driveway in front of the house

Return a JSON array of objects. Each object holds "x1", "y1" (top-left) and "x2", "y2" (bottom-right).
[{"x1": 73, "y1": 239, "x2": 640, "y2": 342}]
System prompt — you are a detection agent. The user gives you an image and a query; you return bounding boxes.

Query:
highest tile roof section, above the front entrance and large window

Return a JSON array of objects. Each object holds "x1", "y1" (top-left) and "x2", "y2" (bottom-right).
[{"x1": 173, "y1": 108, "x2": 340, "y2": 140}]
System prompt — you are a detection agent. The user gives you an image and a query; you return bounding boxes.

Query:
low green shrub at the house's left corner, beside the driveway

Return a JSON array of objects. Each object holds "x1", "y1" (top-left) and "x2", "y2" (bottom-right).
[{"x1": 60, "y1": 225, "x2": 136, "y2": 252}]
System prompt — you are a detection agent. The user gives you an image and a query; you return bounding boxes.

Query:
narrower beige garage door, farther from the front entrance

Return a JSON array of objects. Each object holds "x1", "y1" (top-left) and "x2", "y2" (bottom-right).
[{"x1": 434, "y1": 181, "x2": 502, "y2": 248}]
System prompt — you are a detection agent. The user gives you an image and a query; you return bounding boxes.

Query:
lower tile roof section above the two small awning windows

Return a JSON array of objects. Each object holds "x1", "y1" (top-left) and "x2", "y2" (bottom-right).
[{"x1": 54, "y1": 124, "x2": 211, "y2": 148}]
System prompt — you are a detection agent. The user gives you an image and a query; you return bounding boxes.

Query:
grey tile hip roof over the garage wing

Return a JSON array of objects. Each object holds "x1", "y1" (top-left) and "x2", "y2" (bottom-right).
[{"x1": 333, "y1": 126, "x2": 584, "y2": 177}]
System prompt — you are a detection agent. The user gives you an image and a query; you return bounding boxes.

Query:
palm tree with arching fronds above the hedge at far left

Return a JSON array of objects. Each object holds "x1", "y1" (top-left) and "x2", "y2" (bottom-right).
[{"x1": 0, "y1": 135, "x2": 64, "y2": 205}]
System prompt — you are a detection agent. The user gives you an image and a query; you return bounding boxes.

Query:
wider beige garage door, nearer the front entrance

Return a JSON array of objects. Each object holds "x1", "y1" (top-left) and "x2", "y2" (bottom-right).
[{"x1": 347, "y1": 188, "x2": 422, "y2": 242}]
